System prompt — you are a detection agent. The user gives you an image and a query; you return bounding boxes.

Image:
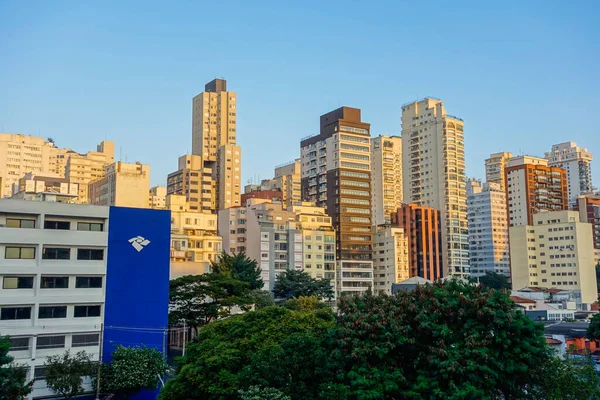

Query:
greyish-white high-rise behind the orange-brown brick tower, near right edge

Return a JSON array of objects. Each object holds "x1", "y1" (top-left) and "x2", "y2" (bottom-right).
[{"x1": 546, "y1": 142, "x2": 594, "y2": 204}]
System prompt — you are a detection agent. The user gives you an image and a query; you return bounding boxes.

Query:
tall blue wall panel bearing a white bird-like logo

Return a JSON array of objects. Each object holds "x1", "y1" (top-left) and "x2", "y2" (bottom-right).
[{"x1": 102, "y1": 207, "x2": 171, "y2": 399}]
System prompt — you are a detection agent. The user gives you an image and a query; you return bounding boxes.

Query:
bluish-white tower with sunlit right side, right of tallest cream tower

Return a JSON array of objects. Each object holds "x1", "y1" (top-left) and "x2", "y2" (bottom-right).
[{"x1": 467, "y1": 179, "x2": 510, "y2": 277}]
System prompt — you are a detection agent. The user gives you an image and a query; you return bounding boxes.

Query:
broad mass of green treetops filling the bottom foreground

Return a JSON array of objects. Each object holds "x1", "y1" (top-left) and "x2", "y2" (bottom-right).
[{"x1": 160, "y1": 280, "x2": 600, "y2": 400}]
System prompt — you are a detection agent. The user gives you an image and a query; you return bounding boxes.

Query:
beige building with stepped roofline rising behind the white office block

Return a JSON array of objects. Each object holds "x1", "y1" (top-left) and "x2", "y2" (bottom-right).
[{"x1": 65, "y1": 140, "x2": 115, "y2": 204}]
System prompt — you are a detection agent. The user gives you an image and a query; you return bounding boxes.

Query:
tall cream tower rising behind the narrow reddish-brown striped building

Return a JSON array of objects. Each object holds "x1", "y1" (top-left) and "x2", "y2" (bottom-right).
[{"x1": 402, "y1": 98, "x2": 469, "y2": 277}]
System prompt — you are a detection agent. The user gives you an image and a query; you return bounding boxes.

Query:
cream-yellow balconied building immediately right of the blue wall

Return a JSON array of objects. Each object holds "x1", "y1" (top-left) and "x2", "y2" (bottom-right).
[{"x1": 166, "y1": 195, "x2": 222, "y2": 279}]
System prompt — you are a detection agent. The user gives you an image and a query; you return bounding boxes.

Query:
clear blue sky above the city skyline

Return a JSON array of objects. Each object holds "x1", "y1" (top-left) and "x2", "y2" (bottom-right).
[{"x1": 0, "y1": 0, "x2": 600, "y2": 186}]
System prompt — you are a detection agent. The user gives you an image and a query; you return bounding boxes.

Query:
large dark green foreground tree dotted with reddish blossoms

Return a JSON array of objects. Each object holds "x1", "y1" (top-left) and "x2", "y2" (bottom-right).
[{"x1": 331, "y1": 280, "x2": 551, "y2": 399}]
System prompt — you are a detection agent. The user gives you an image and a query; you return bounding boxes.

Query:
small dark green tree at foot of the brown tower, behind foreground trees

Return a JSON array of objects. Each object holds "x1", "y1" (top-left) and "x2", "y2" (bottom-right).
[{"x1": 273, "y1": 269, "x2": 334, "y2": 300}]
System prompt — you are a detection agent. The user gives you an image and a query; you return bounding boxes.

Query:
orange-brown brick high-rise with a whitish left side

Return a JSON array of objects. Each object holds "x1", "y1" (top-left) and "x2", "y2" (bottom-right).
[{"x1": 505, "y1": 156, "x2": 569, "y2": 226}]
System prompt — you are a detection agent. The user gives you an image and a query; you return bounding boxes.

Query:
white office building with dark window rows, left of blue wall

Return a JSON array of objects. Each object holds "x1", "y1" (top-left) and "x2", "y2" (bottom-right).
[{"x1": 0, "y1": 200, "x2": 109, "y2": 399}]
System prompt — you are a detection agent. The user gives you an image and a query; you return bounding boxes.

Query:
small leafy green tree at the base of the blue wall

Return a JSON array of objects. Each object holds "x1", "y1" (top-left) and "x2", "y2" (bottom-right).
[{"x1": 100, "y1": 346, "x2": 168, "y2": 399}]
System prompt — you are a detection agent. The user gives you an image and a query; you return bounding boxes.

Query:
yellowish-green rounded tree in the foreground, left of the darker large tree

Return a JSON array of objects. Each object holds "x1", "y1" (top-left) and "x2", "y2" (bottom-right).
[{"x1": 160, "y1": 307, "x2": 335, "y2": 400}]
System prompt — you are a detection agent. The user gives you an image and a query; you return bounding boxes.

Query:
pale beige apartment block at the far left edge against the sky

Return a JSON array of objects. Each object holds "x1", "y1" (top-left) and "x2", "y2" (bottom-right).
[{"x1": 0, "y1": 133, "x2": 58, "y2": 198}]
